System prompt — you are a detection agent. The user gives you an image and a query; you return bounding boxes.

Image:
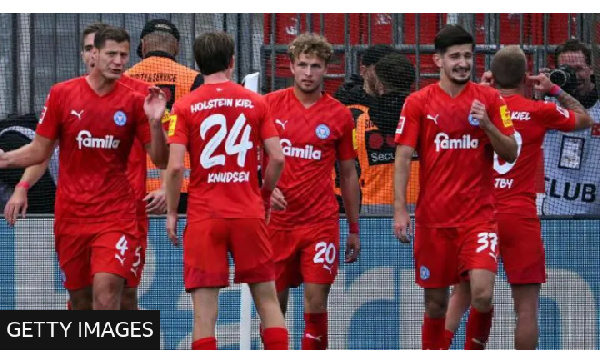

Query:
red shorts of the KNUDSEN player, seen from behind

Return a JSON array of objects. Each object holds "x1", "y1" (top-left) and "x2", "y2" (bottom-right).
[{"x1": 183, "y1": 218, "x2": 275, "y2": 292}]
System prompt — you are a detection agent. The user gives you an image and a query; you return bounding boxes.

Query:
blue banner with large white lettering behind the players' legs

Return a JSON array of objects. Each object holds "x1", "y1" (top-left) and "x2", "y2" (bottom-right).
[{"x1": 0, "y1": 218, "x2": 600, "y2": 349}]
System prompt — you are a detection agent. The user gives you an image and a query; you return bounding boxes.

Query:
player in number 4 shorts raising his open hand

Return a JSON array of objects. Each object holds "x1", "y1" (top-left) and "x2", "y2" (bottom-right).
[{"x1": 0, "y1": 26, "x2": 168, "y2": 310}]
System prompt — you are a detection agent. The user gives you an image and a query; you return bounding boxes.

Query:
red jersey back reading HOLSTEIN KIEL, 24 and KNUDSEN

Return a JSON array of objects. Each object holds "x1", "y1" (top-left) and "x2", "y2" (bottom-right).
[{"x1": 169, "y1": 82, "x2": 277, "y2": 222}]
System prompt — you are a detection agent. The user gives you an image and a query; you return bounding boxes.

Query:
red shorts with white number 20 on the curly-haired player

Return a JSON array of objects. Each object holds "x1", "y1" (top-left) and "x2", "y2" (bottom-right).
[{"x1": 269, "y1": 222, "x2": 340, "y2": 291}]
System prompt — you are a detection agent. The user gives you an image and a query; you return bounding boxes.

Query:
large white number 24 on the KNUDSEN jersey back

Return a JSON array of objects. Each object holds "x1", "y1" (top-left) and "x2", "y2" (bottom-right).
[{"x1": 200, "y1": 113, "x2": 254, "y2": 169}]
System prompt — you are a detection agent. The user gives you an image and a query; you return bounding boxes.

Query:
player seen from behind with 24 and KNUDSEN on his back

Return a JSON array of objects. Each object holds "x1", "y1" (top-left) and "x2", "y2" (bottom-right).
[{"x1": 165, "y1": 32, "x2": 288, "y2": 350}]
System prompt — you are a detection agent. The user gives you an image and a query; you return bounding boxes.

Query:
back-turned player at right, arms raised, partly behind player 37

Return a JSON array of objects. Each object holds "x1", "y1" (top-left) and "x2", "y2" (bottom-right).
[{"x1": 445, "y1": 46, "x2": 592, "y2": 349}]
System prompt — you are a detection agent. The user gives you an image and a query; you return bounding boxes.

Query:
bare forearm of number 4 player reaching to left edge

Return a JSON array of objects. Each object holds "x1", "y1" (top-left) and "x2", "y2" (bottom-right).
[{"x1": 0, "y1": 134, "x2": 54, "y2": 170}]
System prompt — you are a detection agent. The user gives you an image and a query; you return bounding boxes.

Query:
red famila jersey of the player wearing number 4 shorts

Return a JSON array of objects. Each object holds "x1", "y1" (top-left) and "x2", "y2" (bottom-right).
[{"x1": 36, "y1": 77, "x2": 150, "y2": 220}]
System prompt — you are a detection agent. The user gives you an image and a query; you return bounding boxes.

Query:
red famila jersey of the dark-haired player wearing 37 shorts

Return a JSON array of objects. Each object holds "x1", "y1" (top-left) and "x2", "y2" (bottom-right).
[{"x1": 395, "y1": 82, "x2": 514, "y2": 227}]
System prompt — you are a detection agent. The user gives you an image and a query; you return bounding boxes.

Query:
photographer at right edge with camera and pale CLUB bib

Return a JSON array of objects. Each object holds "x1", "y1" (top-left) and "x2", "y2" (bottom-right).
[{"x1": 542, "y1": 39, "x2": 600, "y2": 215}]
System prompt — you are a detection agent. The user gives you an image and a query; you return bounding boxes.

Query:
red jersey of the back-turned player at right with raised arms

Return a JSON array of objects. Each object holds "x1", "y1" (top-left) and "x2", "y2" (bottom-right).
[{"x1": 494, "y1": 95, "x2": 575, "y2": 218}]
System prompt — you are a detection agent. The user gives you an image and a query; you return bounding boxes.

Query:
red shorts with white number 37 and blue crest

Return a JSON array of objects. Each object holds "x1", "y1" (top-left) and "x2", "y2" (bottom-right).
[{"x1": 414, "y1": 222, "x2": 498, "y2": 288}]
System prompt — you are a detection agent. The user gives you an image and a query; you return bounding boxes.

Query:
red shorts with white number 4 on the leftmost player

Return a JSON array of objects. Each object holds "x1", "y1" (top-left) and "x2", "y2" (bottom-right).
[{"x1": 54, "y1": 219, "x2": 138, "y2": 290}]
